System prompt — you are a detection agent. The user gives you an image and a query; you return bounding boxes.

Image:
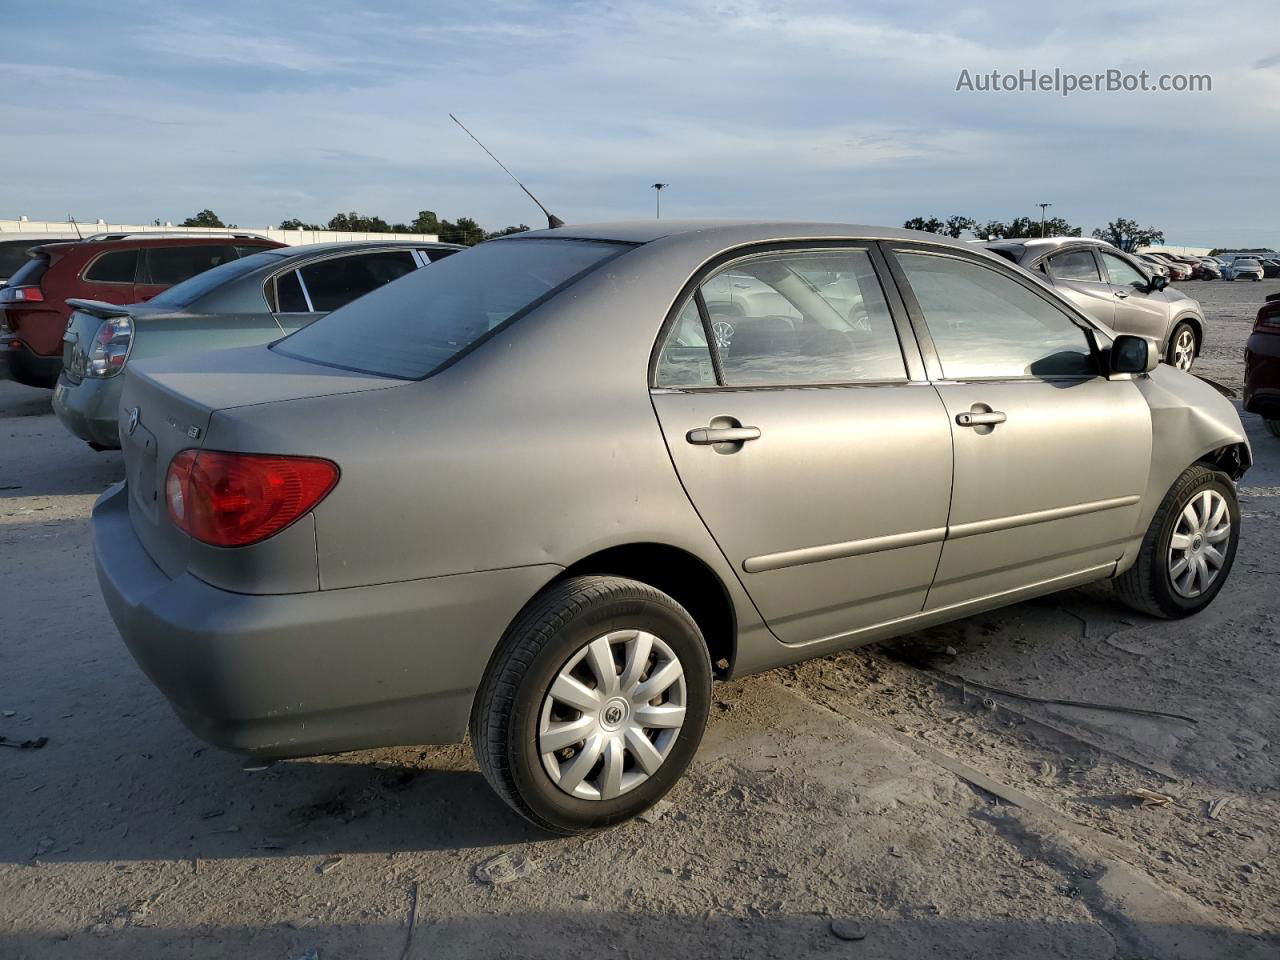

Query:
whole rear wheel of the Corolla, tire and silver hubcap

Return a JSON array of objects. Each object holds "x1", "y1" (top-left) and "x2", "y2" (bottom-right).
[{"x1": 471, "y1": 576, "x2": 712, "y2": 835}]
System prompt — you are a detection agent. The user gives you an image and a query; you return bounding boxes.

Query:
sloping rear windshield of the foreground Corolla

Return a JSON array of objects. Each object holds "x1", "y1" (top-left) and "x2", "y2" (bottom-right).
[{"x1": 271, "y1": 238, "x2": 631, "y2": 380}]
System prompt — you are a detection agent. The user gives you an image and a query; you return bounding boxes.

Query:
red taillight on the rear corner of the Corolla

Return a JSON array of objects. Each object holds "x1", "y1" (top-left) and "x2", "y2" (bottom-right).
[{"x1": 164, "y1": 451, "x2": 338, "y2": 547}]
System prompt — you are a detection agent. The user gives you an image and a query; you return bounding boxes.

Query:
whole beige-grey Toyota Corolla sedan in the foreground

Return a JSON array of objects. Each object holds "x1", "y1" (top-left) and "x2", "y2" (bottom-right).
[{"x1": 93, "y1": 220, "x2": 1251, "y2": 833}]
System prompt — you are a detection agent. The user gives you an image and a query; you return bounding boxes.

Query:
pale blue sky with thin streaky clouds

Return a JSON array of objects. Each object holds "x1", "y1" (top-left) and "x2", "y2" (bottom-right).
[{"x1": 0, "y1": 0, "x2": 1280, "y2": 247}]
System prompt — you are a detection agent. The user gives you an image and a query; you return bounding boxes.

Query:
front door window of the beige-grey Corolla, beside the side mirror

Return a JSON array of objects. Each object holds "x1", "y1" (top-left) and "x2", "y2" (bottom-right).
[{"x1": 897, "y1": 251, "x2": 1097, "y2": 380}]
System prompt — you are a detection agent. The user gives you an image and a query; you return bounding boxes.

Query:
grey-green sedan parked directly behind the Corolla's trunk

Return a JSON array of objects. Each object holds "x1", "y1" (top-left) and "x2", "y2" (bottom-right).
[{"x1": 54, "y1": 241, "x2": 465, "y2": 449}]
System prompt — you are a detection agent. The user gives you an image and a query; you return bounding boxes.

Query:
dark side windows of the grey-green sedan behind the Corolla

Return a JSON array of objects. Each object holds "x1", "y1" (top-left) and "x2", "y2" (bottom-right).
[{"x1": 271, "y1": 250, "x2": 424, "y2": 333}]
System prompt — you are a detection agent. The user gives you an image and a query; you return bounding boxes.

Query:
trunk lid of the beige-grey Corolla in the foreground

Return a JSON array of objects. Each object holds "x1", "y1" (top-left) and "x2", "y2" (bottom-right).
[{"x1": 120, "y1": 346, "x2": 404, "y2": 577}]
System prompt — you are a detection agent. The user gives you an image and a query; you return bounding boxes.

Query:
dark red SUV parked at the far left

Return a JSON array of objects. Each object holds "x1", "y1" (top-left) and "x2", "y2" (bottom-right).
[{"x1": 0, "y1": 233, "x2": 285, "y2": 389}]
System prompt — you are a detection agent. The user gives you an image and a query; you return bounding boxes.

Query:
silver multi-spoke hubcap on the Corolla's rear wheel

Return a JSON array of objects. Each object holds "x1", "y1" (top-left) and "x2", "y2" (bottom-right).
[{"x1": 538, "y1": 630, "x2": 686, "y2": 800}]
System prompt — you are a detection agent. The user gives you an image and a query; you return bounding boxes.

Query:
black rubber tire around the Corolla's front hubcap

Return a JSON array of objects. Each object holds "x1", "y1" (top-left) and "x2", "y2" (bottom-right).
[{"x1": 1112, "y1": 463, "x2": 1240, "y2": 620}]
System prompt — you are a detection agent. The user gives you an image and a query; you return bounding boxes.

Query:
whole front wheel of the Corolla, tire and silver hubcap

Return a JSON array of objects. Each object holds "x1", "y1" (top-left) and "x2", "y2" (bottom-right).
[{"x1": 1115, "y1": 463, "x2": 1240, "y2": 620}]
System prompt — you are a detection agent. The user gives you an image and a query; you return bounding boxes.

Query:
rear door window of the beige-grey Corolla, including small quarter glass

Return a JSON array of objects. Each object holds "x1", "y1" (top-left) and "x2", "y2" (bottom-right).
[{"x1": 659, "y1": 250, "x2": 906, "y2": 387}]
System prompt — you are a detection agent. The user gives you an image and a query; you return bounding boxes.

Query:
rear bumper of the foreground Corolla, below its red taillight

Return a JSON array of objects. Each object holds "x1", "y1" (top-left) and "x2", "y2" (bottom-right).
[{"x1": 92, "y1": 484, "x2": 559, "y2": 758}]
